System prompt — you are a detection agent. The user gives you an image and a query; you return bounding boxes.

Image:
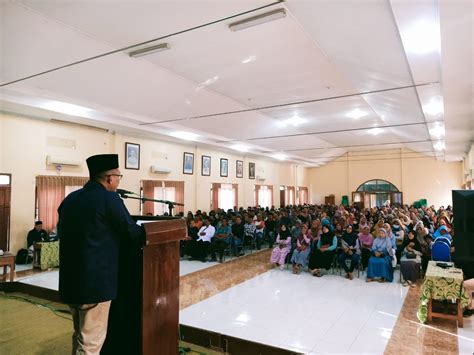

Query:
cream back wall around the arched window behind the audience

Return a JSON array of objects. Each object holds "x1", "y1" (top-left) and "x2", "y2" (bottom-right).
[{"x1": 308, "y1": 150, "x2": 462, "y2": 206}]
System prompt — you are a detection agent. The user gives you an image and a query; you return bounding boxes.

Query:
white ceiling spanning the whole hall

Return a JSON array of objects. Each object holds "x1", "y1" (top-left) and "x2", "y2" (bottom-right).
[{"x1": 0, "y1": 0, "x2": 474, "y2": 166}]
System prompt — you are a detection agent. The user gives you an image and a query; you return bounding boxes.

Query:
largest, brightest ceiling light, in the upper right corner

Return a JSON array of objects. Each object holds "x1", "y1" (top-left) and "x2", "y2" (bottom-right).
[{"x1": 401, "y1": 20, "x2": 441, "y2": 54}]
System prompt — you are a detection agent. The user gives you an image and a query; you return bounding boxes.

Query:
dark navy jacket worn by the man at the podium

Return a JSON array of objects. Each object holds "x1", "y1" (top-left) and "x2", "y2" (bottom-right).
[{"x1": 58, "y1": 181, "x2": 144, "y2": 304}]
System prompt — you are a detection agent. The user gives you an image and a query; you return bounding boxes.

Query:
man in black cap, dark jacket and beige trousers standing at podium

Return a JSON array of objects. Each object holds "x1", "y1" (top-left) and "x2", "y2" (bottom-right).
[{"x1": 58, "y1": 154, "x2": 144, "y2": 354}]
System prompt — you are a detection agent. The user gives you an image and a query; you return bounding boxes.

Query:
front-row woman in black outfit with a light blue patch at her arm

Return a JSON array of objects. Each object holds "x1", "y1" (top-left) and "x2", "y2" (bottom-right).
[{"x1": 308, "y1": 224, "x2": 337, "y2": 277}]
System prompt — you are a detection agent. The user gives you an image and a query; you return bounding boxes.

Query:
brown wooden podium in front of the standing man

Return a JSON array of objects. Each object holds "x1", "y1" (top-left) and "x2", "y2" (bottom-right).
[{"x1": 101, "y1": 216, "x2": 186, "y2": 355}]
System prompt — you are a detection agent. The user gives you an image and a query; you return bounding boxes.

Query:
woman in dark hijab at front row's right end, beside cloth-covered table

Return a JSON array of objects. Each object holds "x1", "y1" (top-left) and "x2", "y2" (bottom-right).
[{"x1": 400, "y1": 230, "x2": 422, "y2": 286}]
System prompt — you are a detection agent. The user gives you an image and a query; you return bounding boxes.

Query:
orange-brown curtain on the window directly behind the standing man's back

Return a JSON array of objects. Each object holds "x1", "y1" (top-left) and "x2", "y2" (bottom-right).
[{"x1": 36, "y1": 175, "x2": 89, "y2": 232}]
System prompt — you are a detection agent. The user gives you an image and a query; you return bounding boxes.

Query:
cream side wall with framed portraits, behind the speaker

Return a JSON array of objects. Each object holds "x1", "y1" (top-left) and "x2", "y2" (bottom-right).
[{"x1": 0, "y1": 114, "x2": 309, "y2": 252}]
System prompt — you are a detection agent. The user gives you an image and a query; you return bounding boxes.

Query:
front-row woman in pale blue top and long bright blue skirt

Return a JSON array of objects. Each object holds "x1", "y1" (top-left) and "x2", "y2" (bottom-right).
[{"x1": 367, "y1": 228, "x2": 393, "y2": 282}]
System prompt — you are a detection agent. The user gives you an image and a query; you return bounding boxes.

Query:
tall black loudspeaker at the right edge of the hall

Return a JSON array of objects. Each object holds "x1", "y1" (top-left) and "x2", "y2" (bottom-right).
[{"x1": 453, "y1": 190, "x2": 474, "y2": 278}]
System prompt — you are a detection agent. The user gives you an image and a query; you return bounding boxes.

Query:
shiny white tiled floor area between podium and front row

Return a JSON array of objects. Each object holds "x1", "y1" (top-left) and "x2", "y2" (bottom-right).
[{"x1": 180, "y1": 270, "x2": 407, "y2": 354}]
